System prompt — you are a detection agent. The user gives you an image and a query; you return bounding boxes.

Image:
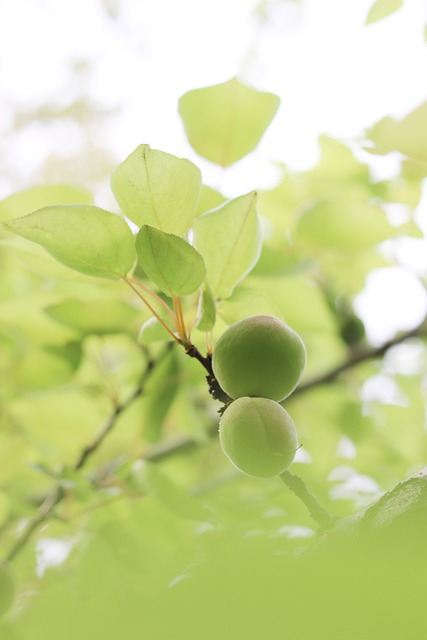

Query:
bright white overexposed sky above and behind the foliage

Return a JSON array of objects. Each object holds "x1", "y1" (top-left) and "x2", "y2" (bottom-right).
[{"x1": 0, "y1": 0, "x2": 427, "y2": 340}]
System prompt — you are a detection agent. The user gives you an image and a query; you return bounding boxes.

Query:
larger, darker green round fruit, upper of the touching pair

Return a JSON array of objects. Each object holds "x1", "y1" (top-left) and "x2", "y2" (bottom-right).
[{"x1": 212, "y1": 315, "x2": 306, "y2": 402}]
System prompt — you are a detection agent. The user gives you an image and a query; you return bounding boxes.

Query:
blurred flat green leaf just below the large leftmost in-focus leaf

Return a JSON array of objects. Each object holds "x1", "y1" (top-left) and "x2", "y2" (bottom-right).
[{"x1": 45, "y1": 298, "x2": 139, "y2": 335}]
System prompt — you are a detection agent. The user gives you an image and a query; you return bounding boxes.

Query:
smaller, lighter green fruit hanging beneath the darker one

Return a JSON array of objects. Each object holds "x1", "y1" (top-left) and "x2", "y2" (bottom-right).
[{"x1": 219, "y1": 397, "x2": 298, "y2": 478}]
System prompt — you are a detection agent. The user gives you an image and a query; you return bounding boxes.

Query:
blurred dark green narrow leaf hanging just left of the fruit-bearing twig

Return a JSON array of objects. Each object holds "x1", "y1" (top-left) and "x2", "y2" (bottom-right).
[{"x1": 144, "y1": 350, "x2": 181, "y2": 442}]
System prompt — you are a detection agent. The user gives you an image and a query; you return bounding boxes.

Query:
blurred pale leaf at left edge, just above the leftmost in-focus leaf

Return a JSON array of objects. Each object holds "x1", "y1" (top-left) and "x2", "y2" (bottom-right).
[{"x1": 0, "y1": 184, "x2": 93, "y2": 220}]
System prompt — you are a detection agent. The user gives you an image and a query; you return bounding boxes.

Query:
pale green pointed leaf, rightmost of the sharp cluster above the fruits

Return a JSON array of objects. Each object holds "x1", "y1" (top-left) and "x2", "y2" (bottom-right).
[{"x1": 194, "y1": 191, "x2": 262, "y2": 298}]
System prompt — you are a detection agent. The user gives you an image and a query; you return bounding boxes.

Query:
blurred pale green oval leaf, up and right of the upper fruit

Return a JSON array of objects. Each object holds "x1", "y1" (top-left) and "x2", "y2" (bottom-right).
[{"x1": 294, "y1": 201, "x2": 395, "y2": 252}]
